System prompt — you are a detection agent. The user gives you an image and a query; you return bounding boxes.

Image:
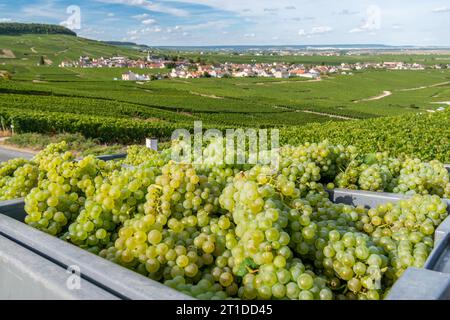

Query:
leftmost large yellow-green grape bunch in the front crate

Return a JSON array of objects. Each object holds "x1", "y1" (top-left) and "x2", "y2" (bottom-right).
[{"x1": 25, "y1": 146, "x2": 118, "y2": 236}]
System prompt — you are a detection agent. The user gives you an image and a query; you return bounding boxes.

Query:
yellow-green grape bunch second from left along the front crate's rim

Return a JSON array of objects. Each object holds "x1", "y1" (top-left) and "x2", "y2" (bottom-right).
[{"x1": 65, "y1": 164, "x2": 158, "y2": 253}]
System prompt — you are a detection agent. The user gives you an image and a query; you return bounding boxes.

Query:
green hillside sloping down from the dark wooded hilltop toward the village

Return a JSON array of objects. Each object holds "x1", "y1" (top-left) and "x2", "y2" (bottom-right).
[{"x1": 0, "y1": 34, "x2": 143, "y2": 65}]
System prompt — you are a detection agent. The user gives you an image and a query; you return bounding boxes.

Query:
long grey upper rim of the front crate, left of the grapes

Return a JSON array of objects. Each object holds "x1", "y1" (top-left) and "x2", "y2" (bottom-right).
[{"x1": 0, "y1": 200, "x2": 192, "y2": 300}]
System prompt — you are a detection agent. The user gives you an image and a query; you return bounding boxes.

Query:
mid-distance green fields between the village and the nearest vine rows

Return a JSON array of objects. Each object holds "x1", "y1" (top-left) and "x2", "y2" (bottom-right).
[{"x1": 0, "y1": 66, "x2": 450, "y2": 126}]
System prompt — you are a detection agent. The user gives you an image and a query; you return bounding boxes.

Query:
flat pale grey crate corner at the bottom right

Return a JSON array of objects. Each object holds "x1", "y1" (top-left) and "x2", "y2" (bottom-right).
[{"x1": 386, "y1": 267, "x2": 450, "y2": 300}]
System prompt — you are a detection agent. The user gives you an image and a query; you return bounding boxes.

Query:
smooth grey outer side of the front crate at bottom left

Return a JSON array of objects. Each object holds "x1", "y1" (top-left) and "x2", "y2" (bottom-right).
[{"x1": 0, "y1": 235, "x2": 118, "y2": 300}]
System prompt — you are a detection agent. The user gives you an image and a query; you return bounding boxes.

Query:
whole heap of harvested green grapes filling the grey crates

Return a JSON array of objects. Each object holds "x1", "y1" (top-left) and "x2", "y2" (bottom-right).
[{"x1": 17, "y1": 141, "x2": 448, "y2": 300}]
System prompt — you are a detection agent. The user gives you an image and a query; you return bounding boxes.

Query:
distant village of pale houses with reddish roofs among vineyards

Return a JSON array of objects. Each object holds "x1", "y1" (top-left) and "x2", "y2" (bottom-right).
[{"x1": 59, "y1": 53, "x2": 450, "y2": 81}]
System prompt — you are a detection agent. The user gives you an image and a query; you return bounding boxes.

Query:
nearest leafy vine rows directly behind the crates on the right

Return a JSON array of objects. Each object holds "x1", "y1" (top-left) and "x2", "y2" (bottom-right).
[{"x1": 282, "y1": 110, "x2": 450, "y2": 163}]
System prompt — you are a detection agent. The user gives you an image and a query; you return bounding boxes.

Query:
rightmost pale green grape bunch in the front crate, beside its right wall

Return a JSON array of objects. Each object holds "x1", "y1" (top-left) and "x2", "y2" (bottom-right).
[{"x1": 359, "y1": 195, "x2": 448, "y2": 284}]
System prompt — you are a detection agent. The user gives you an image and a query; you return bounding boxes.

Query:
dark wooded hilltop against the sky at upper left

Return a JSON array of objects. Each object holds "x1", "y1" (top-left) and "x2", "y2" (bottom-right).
[{"x1": 0, "y1": 22, "x2": 77, "y2": 36}]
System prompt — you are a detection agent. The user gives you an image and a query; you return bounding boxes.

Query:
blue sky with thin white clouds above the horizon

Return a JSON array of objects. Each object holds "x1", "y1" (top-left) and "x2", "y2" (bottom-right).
[{"x1": 0, "y1": 0, "x2": 450, "y2": 46}]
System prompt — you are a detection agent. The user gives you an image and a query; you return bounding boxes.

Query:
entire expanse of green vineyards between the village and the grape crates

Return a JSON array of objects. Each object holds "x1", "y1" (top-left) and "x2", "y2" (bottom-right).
[{"x1": 0, "y1": 66, "x2": 450, "y2": 154}]
